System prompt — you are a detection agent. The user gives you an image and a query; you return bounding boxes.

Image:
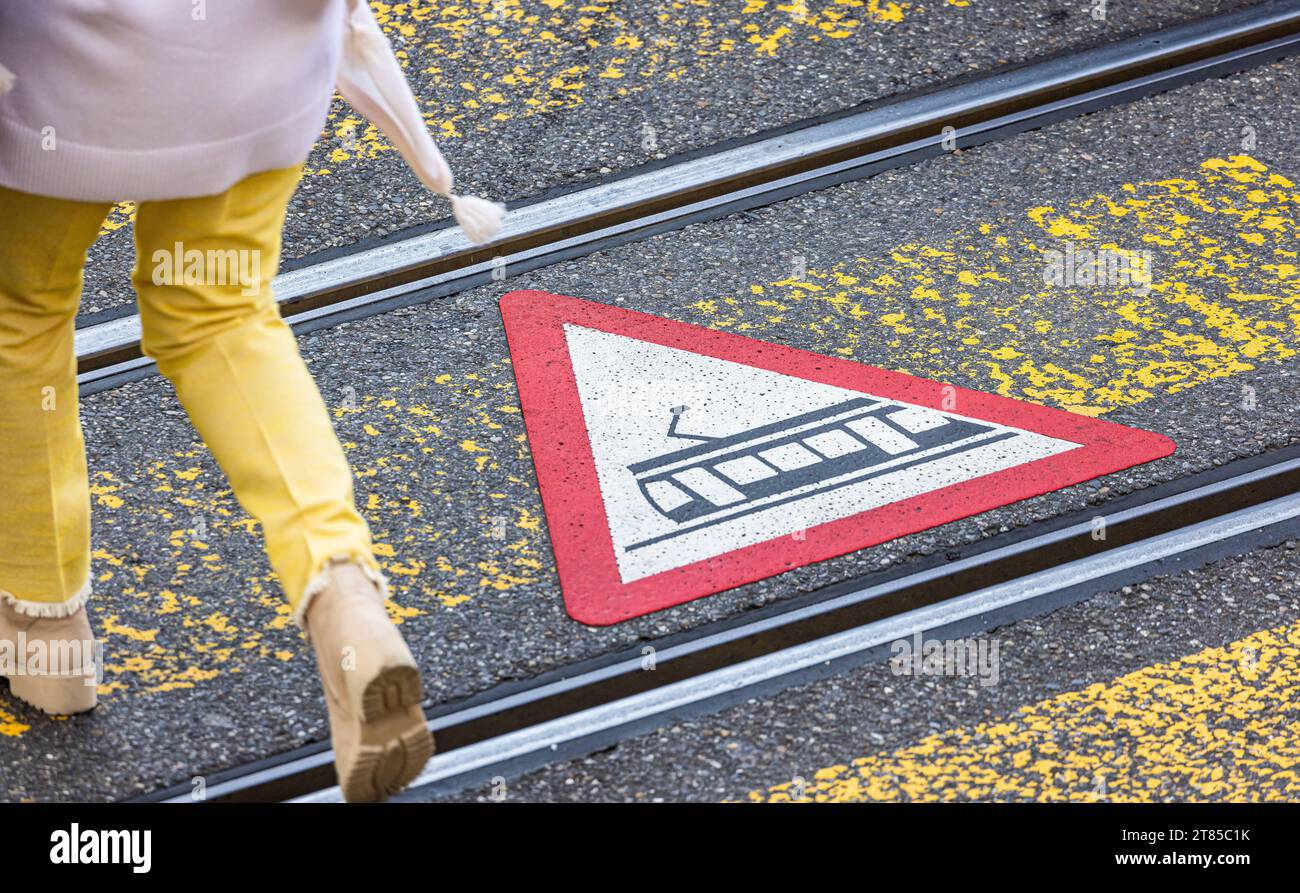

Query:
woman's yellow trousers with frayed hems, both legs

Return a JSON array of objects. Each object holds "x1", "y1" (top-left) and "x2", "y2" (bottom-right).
[{"x1": 0, "y1": 168, "x2": 378, "y2": 621}]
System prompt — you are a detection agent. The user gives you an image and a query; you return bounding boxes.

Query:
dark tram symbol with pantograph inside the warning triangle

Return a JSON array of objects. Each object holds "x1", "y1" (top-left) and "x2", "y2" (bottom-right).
[{"x1": 627, "y1": 396, "x2": 998, "y2": 538}]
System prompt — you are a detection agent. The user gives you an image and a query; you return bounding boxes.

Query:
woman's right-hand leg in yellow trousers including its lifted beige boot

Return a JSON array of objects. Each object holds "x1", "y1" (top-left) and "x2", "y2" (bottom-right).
[{"x1": 133, "y1": 169, "x2": 433, "y2": 801}]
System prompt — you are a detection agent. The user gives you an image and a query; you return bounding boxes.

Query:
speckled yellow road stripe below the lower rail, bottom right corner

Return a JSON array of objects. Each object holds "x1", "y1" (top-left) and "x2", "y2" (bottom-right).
[{"x1": 749, "y1": 624, "x2": 1300, "y2": 802}]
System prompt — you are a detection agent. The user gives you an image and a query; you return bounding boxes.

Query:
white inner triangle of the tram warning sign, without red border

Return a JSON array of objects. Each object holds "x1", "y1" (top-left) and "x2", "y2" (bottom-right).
[{"x1": 564, "y1": 324, "x2": 1079, "y2": 582}]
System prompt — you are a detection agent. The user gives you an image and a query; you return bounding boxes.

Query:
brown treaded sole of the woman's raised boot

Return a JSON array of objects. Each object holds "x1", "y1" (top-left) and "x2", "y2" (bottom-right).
[{"x1": 339, "y1": 666, "x2": 434, "y2": 803}]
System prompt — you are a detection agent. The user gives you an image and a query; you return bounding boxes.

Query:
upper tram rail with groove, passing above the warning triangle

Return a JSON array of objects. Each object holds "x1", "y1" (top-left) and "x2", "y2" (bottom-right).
[{"x1": 75, "y1": 0, "x2": 1300, "y2": 393}]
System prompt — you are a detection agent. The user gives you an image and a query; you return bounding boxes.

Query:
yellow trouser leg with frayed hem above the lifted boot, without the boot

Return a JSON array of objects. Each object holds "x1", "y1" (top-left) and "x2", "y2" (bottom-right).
[{"x1": 131, "y1": 169, "x2": 377, "y2": 620}]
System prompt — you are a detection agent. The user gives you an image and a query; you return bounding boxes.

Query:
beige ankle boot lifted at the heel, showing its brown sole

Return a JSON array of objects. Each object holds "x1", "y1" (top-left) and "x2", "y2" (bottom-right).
[{"x1": 307, "y1": 562, "x2": 433, "y2": 803}]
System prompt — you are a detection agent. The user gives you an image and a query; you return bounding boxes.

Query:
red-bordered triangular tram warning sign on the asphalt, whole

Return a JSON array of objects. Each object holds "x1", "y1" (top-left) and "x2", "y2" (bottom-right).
[{"x1": 501, "y1": 291, "x2": 1174, "y2": 625}]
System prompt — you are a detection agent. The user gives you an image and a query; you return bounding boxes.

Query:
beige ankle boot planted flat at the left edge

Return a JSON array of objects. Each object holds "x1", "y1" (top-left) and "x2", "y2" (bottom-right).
[{"x1": 0, "y1": 598, "x2": 99, "y2": 716}]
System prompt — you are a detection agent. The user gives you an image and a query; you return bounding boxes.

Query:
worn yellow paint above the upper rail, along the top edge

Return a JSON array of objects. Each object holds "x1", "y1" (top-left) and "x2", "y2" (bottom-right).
[{"x1": 308, "y1": 0, "x2": 935, "y2": 174}]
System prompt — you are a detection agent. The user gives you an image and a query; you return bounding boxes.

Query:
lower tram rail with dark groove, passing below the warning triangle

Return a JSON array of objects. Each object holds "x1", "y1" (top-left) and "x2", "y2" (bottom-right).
[{"x1": 139, "y1": 447, "x2": 1300, "y2": 802}]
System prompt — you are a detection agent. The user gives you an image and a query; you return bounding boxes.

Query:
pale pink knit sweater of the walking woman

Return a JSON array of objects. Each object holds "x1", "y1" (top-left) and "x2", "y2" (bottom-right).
[{"x1": 0, "y1": 0, "x2": 346, "y2": 201}]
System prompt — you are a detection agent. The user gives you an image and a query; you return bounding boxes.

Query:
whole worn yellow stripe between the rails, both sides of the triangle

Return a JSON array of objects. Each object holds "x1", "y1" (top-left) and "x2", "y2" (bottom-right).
[{"x1": 0, "y1": 156, "x2": 1300, "y2": 729}]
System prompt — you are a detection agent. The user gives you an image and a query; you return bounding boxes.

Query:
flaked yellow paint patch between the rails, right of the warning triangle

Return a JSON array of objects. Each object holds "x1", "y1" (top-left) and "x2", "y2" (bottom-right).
[{"x1": 694, "y1": 156, "x2": 1300, "y2": 416}]
